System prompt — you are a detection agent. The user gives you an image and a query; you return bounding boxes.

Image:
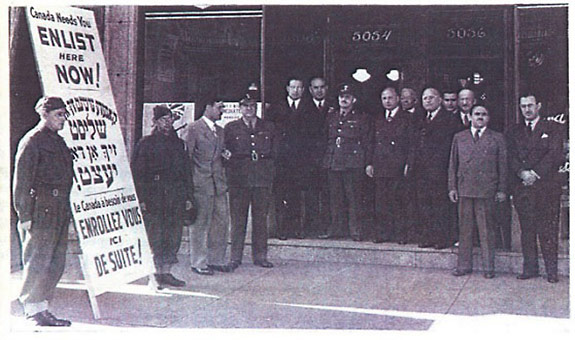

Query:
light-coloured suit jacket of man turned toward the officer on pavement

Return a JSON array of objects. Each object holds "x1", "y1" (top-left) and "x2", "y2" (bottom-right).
[{"x1": 186, "y1": 119, "x2": 228, "y2": 195}]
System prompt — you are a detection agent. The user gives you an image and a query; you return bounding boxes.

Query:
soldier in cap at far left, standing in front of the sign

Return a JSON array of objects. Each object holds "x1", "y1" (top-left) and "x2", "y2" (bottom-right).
[{"x1": 13, "y1": 97, "x2": 74, "y2": 326}]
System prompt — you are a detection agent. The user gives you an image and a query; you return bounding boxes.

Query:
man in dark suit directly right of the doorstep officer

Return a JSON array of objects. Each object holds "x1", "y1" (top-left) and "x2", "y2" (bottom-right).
[{"x1": 365, "y1": 87, "x2": 412, "y2": 244}]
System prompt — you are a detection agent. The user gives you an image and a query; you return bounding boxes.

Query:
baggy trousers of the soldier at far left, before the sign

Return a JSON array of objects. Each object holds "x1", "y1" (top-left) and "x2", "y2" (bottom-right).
[{"x1": 18, "y1": 196, "x2": 71, "y2": 316}]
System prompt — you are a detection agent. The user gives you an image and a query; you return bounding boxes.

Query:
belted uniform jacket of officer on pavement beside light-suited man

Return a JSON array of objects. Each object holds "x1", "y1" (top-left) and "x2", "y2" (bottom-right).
[{"x1": 225, "y1": 118, "x2": 278, "y2": 187}]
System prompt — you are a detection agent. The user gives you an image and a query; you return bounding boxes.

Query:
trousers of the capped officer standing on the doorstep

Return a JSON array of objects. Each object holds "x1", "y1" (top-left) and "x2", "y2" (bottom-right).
[{"x1": 328, "y1": 168, "x2": 363, "y2": 238}]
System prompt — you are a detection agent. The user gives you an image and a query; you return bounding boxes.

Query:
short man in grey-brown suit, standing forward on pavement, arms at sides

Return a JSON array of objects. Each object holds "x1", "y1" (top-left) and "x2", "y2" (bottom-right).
[{"x1": 447, "y1": 105, "x2": 508, "y2": 279}]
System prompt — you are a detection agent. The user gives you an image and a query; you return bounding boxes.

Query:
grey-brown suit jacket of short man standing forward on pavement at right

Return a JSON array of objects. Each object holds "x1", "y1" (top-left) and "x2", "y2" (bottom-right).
[{"x1": 447, "y1": 129, "x2": 508, "y2": 198}]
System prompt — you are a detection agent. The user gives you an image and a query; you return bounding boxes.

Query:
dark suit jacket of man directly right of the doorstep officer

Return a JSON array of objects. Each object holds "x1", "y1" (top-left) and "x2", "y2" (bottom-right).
[{"x1": 367, "y1": 109, "x2": 413, "y2": 178}]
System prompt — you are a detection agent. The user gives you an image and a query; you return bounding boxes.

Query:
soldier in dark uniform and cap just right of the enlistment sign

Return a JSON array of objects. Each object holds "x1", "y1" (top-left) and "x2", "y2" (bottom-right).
[{"x1": 132, "y1": 105, "x2": 193, "y2": 289}]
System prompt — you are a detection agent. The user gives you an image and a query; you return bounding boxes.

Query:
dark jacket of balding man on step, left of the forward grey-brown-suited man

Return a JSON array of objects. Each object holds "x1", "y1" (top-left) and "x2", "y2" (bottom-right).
[{"x1": 408, "y1": 109, "x2": 459, "y2": 183}]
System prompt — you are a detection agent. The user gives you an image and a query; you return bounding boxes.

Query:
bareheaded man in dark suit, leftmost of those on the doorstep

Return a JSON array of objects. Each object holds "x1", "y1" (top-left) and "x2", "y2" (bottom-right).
[{"x1": 268, "y1": 78, "x2": 308, "y2": 240}]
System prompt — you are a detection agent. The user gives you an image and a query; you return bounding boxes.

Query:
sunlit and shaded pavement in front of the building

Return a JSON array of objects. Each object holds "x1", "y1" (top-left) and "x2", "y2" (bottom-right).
[{"x1": 5, "y1": 247, "x2": 575, "y2": 339}]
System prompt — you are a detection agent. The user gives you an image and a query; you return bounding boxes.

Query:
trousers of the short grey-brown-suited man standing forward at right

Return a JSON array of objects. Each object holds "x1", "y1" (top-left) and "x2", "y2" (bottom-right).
[{"x1": 457, "y1": 196, "x2": 495, "y2": 272}]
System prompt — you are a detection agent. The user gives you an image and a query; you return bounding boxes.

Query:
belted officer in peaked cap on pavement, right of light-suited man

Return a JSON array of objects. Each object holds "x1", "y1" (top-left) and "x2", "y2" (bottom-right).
[{"x1": 224, "y1": 97, "x2": 277, "y2": 269}]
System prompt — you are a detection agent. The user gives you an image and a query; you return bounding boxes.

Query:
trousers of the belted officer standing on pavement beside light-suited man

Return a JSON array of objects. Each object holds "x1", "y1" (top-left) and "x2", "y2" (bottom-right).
[{"x1": 230, "y1": 187, "x2": 272, "y2": 263}]
